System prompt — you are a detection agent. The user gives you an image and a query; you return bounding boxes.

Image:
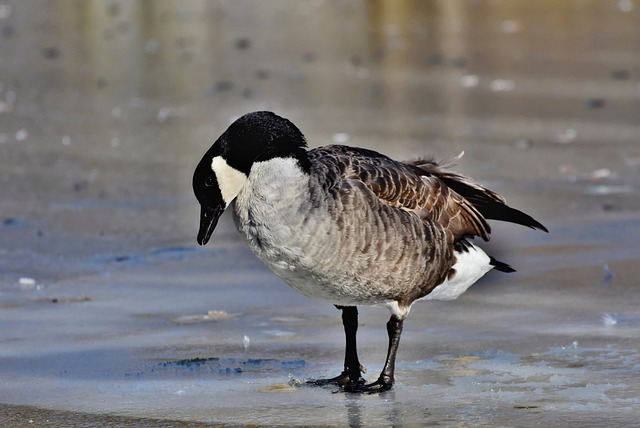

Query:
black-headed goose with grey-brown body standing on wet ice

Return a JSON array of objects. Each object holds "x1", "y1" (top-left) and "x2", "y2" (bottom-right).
[{"x1": 193, "y1": 111, "x2": 547, "y2": 393}]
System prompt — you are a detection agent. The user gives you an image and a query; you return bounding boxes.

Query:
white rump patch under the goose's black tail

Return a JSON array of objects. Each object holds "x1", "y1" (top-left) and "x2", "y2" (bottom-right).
[{"x1": 420, "y1": 245, "x2": 493, "y2": 300}]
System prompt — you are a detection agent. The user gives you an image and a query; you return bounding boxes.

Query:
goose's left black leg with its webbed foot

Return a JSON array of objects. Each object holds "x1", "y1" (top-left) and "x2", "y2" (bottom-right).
[{"x1": 310, "y1": 306, "x2": 365, "y2": 389}]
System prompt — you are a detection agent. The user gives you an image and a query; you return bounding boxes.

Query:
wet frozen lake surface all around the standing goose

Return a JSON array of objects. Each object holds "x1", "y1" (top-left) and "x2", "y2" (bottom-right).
[{"x1": 0, "y1": 0, "x2": 640, "y2": 427}]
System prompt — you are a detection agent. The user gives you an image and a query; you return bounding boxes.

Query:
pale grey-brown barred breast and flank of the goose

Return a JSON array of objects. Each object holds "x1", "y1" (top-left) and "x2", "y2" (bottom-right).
[{"x1": 234, "y1": 151, "x2": 452, "y2": 305}]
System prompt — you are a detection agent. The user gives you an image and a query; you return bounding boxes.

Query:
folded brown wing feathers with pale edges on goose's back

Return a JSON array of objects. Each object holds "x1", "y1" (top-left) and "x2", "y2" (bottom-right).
[{"x1": 310, "y1": 146, "x2": 491, "y2": 241}]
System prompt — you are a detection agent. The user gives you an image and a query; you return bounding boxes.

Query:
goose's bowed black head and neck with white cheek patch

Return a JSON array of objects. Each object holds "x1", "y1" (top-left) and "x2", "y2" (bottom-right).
[{"x1": 193, "y1": 111, "x2": 309, "y2": 245}]
